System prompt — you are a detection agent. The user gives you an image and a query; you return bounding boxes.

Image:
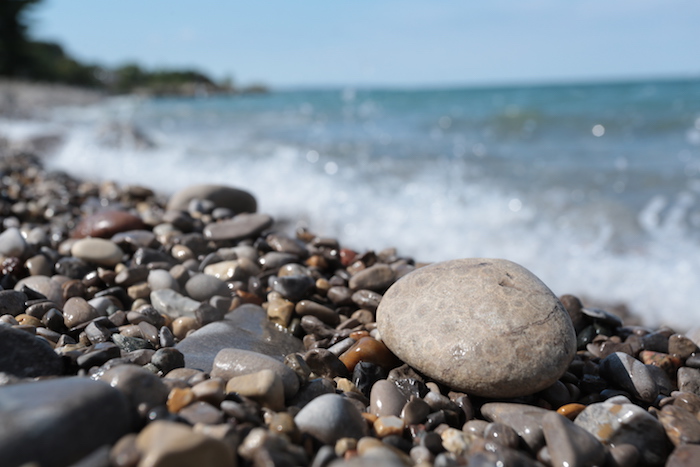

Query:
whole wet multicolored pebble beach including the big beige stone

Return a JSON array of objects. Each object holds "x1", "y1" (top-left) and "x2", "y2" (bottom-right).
[{"x1": 0, "y1": 154, "x2": 700, "y2": 467}]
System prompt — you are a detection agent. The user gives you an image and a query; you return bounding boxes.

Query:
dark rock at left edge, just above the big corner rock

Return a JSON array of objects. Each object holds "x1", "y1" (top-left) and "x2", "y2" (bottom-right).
[{"x1": 0, "y1": 325, "x2": 63, "y2": 378}]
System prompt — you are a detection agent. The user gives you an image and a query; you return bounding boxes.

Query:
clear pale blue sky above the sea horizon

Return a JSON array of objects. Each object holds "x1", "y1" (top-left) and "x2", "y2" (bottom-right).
[{"x1": 32, "y1": 0, "x2": 700, "y2": 87}]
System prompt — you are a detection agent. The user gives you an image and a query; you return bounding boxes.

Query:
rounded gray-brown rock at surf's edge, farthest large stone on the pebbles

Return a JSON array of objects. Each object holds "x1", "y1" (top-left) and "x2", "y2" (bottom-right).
[{"x1": 166, "y1": 185, "x2": 257, "y2": 217}]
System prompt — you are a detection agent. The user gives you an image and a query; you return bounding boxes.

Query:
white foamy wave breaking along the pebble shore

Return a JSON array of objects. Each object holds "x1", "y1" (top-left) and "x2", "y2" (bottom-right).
[{"x1": 31, "y1": 98, "x2": 700, "y2": 330}]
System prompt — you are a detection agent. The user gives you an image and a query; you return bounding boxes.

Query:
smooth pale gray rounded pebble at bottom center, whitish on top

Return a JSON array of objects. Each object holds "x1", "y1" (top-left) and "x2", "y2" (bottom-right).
[{"x1": 294, "y1": 394, "x2": 368, "y2": 444}]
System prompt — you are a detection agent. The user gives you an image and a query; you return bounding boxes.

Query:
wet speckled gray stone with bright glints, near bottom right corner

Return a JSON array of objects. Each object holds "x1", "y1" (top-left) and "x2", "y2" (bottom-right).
[{"x1": 574, "y1": 396, "x2": 667, "y2": 465}]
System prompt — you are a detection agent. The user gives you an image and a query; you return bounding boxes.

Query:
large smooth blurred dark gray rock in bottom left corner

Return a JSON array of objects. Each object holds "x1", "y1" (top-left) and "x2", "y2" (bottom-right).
[{"x1": 0, "y1": 377, "x2": 132, "y2": 467}]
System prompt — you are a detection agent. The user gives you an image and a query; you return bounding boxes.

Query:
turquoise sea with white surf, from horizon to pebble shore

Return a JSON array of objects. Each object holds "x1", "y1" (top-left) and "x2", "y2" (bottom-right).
[{"x1": 28, "y1": 80, "x2": 700, "y2": 328}]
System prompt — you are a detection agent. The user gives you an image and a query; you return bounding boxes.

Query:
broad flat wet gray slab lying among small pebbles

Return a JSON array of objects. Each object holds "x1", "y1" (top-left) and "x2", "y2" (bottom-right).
[{"x1": 177, "y1": 304, "x2": 304, "y2": 372}]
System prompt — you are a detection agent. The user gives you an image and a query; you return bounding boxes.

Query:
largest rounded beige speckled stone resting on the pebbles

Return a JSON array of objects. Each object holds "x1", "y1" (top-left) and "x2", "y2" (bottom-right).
[{"x1": 377, "y1": 259, "x2": 576, "y2": 397}]
